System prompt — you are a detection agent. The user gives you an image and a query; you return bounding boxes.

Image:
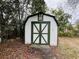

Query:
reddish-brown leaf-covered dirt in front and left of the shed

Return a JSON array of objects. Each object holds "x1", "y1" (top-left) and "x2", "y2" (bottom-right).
[{"x1": 0, "y1": 39, "x2": 57, "y2": 59}]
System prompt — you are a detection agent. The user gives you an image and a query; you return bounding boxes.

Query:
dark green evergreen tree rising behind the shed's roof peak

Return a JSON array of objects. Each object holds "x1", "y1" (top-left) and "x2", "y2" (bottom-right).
[{"x1": 31, "y1": 0, "x2": 47, "y2": 14}]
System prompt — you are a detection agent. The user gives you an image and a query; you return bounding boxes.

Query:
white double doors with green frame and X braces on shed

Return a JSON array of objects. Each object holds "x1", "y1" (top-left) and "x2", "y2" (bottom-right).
[{"x1": 31, "y1": 22, "x2": 50, "y2": 44}]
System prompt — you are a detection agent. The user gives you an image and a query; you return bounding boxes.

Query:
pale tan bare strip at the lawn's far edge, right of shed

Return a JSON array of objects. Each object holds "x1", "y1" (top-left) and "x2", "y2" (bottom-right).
[{"x1": 59, "y1": 37, "x2": 79, "y2": 49}]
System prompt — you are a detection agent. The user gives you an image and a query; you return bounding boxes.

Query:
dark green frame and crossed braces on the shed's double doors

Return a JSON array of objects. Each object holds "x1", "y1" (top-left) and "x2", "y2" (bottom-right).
[{"x1": 31, "y1": 21, "x2": 50, "y2": 45}]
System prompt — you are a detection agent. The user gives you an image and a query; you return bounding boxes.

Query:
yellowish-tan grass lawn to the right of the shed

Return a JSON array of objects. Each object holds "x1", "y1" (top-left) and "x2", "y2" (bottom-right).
[{"x1": 58, "y1": 37, "x2": 79, "y2": 59}]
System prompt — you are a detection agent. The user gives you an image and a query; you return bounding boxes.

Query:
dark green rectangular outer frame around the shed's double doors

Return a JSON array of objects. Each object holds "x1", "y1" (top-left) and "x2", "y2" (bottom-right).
[{"x1": 31, "y1": 21, "x2": 50, "y2": 45}]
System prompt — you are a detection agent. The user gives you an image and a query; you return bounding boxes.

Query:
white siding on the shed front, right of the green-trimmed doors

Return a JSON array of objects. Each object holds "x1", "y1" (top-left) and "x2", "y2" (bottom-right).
[{"x1": 44, "y1": 16, "x2": 57, "y2": 46}]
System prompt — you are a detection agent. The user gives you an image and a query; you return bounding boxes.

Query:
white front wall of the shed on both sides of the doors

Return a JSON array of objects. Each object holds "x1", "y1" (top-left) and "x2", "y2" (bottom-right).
[{"x1": 25, "y1": 15, "x2": 57, "y2": 46}]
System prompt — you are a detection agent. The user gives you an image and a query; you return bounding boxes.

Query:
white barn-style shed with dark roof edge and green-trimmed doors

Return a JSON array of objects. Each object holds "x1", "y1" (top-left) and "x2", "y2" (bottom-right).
[{"x1": 24, "y1": 12, "x2": 58, "y2": 46}]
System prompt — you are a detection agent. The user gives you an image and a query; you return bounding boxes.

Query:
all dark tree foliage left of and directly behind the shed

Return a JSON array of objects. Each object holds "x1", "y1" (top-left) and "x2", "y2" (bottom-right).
[{"x1": 0, "y1": 0, "x2": 46, "y2": 41}]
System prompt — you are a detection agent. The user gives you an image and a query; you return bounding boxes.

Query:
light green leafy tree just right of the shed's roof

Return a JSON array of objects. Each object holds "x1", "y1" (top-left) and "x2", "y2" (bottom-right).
[{"x1": 52, "y1": 9, "x2": 71, "y2": 35}]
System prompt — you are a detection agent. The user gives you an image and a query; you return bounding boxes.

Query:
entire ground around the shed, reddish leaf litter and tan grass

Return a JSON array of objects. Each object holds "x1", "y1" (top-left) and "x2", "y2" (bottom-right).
[{"x1": 0, "y1": 37, "x2": 79, "y2": 59}]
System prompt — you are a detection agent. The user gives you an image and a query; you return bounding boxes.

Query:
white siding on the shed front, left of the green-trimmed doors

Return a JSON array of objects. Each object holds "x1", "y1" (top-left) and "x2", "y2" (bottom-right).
[{"x1": 25, "y1": 16, "x2": 38, "y2": 44}]
